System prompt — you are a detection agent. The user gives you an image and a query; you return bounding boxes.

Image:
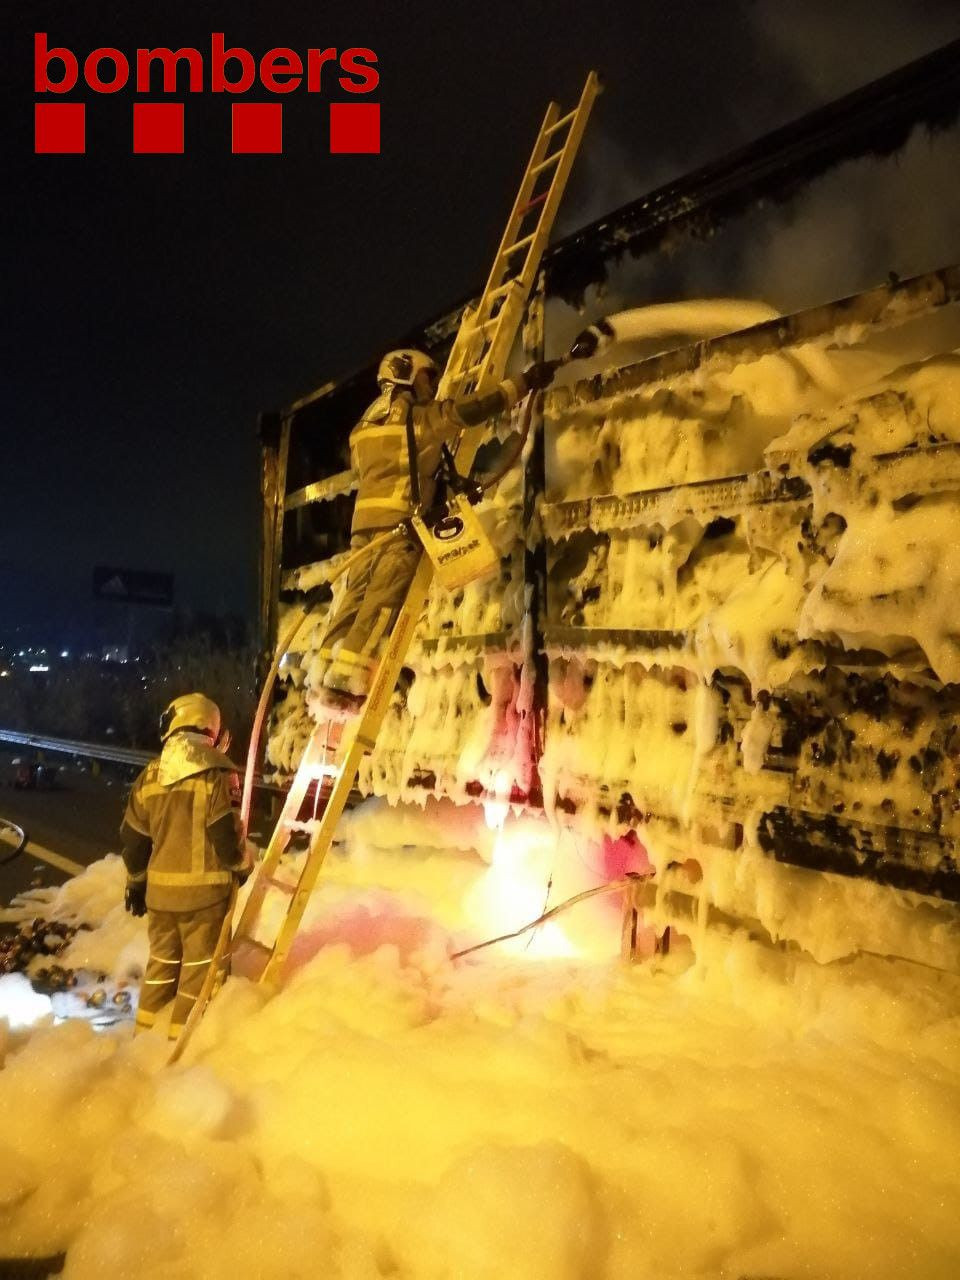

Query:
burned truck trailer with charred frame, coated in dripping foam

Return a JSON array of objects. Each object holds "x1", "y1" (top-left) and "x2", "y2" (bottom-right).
[{"x1": 253, "y1": 50, "x2": 960, "y2": 970}]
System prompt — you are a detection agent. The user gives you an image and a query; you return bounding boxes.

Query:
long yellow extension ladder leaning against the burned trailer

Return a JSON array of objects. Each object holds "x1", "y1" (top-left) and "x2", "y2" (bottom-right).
[{"x1": 168, "y1": 64, "x2": 600, "y2": 1057}]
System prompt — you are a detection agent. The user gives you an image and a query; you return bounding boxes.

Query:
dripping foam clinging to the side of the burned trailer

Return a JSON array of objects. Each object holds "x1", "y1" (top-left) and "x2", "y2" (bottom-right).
[{"x1": 259, "y1": 288, "x2": 960, "y2": 968}]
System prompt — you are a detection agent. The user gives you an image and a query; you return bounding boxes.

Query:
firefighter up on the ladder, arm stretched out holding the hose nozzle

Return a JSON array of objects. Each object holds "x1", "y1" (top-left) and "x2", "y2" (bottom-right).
[{"x1": 317, "y1": 349, "x2": 557, "y2": 714}]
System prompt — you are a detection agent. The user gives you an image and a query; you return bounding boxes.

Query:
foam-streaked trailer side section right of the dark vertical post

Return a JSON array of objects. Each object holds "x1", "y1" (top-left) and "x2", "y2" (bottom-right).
[{"x1": 541, "y1": 270, "x2": 960, "y2": 968}]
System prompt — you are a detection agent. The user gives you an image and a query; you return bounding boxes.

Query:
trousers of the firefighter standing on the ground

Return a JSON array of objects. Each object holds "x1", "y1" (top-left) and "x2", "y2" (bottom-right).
[{"x1": 137, "y1": 897, "x2": 230, "y2": 1039}]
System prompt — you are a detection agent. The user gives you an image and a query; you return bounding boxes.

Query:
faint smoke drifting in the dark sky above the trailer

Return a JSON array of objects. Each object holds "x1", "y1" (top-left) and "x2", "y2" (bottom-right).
[{"x1": 547, "y1": 0, "x2": 960, "y2": 353}]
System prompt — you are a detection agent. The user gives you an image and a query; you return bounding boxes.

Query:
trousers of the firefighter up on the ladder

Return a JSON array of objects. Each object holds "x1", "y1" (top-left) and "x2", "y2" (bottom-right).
[{"x1": 321, "y1": 529, "x2": 420, "y2": 698}]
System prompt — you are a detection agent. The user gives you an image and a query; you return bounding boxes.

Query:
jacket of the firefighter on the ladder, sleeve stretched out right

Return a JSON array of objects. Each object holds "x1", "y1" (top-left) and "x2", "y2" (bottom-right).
[{"x1": 349, "y1": 380, "x2": 525, "y2": 534}]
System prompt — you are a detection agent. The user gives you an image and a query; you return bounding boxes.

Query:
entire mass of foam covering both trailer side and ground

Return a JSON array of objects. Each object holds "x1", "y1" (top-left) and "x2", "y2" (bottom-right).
[{"x1": 84, "y1": 294, "x2": 960, "y2": 1280}]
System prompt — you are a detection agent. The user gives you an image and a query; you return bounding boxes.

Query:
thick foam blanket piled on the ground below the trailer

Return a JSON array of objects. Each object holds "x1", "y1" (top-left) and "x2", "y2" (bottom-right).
[{"x1": 0, "y1": 839, "x2": 960, "y2": 1280}]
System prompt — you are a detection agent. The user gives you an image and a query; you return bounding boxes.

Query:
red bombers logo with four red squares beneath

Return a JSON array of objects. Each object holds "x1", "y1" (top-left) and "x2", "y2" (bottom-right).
[{"x1": 33, "y1": 31, "x2": 380, "y2": 155}]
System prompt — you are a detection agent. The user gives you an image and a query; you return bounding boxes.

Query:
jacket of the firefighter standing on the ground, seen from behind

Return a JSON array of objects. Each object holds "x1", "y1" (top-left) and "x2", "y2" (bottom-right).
[{"x1": 120, "y1": 732, "x2": 243, "y2": 911}]
